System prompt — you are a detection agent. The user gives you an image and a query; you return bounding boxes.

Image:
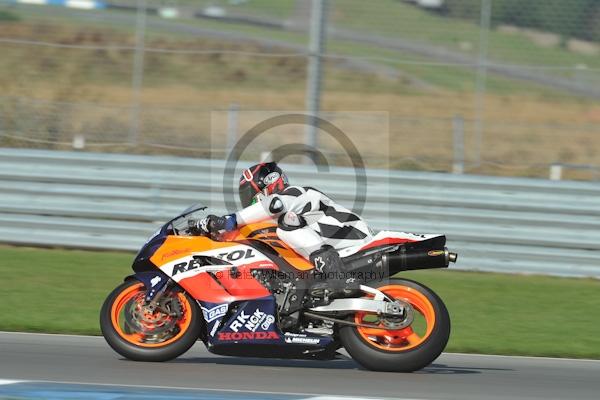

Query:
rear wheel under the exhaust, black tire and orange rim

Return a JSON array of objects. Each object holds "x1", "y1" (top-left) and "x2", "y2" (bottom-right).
[{"x1": 339, "y1": 279, "x2": 450, "y2": 372}]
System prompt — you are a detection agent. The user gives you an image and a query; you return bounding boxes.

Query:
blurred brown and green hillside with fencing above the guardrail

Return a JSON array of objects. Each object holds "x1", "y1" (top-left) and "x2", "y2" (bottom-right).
[{"x1": 0, "y1": 0, "x2": 600, "y2": 180}]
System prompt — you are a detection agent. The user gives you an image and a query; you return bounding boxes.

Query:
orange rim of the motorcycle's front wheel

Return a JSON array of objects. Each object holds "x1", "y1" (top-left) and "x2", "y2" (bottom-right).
[{"x1": 110, "y1": 283, "x2": 191, "y2": 347}]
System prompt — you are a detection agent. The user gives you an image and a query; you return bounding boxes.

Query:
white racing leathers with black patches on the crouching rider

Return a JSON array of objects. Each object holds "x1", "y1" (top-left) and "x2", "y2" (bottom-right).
[{"x1": 235, "y1": 186, "x2": 373, "y2": 258}]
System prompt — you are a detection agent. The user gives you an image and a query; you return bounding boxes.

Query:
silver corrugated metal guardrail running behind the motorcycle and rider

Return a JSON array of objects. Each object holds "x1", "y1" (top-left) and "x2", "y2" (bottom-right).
[{"x1": 0, "y1": 149, "x2": 600, "y2": 277}]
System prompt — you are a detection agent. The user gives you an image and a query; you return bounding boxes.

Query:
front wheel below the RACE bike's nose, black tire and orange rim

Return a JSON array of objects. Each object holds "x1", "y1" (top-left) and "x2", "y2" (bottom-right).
[{"x1": 100, "y1": 280, "x2": 202, "y2": 361}]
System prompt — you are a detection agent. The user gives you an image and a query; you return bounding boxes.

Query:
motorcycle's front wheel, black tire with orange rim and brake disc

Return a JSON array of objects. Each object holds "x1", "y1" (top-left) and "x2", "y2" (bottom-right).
[{"x1": 100, "y1": 280, "x2": 202, "y2": 361}]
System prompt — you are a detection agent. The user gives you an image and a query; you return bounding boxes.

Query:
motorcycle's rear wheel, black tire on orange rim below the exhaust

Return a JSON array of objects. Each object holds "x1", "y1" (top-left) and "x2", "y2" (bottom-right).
[{"x1": 340, "y1": 279, "x2": 450, "y2": 372}]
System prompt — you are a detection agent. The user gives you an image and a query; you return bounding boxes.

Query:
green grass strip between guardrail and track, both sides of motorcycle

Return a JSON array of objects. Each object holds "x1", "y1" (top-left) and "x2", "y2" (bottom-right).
[{"x1": 0, "y1": 247, "x2": 600, "y2": 358}]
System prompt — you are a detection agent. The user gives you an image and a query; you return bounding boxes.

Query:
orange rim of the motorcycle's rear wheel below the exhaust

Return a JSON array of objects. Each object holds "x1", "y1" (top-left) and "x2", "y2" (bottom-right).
[{"x1": 354, "y1": 285, "x2": 435, "y2": 351}]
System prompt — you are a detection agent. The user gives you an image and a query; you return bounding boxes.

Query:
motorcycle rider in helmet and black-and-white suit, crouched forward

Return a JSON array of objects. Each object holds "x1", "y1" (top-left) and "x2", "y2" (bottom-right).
[{"x1": 196, "y1": 162, "x2": 372, "y2": 297}]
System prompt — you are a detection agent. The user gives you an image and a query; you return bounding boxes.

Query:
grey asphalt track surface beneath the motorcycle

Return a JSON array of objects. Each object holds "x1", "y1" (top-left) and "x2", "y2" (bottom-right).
[{"x1": 0, "y1": 332, "x2": 600, "y2": 400}]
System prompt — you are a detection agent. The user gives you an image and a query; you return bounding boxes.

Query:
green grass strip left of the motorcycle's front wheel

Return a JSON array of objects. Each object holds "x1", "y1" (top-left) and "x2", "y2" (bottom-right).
[{"x1": 0, "y1": 247, "x2": 133, "y2": 335}]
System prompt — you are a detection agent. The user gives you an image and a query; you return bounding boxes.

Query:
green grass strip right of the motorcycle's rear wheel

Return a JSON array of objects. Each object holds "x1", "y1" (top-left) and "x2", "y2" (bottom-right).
[{"x1": 403, "y1": 271, "x2": 600, "y2": 358}]
